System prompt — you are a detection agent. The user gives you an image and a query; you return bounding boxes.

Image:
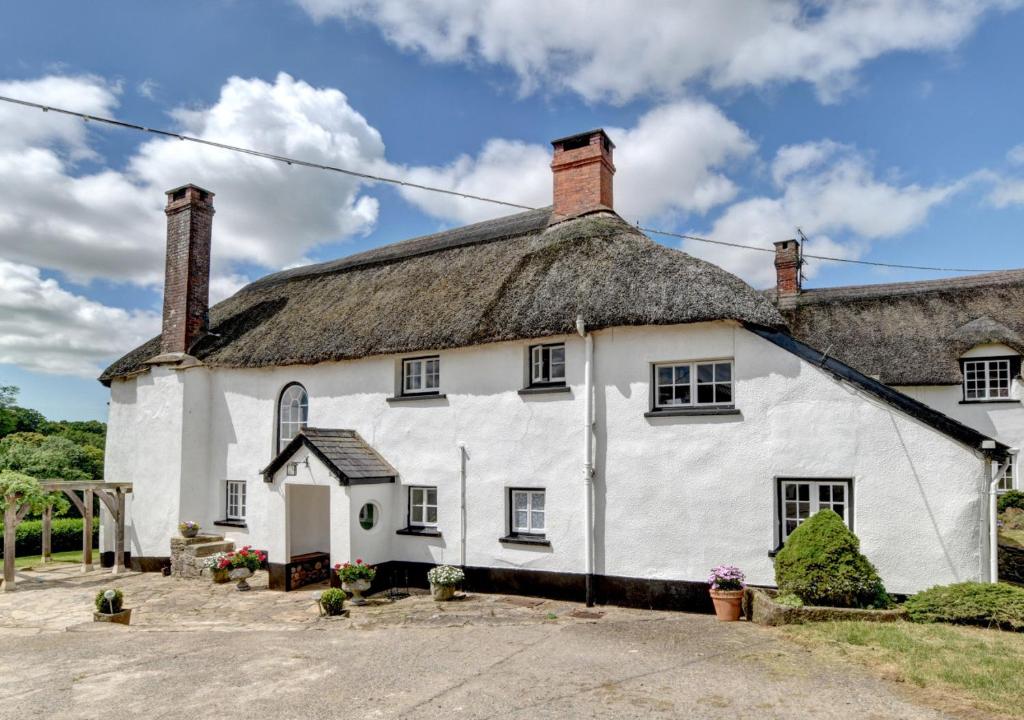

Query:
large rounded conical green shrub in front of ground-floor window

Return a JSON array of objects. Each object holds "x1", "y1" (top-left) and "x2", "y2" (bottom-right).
[{"x1": 775, "y1": 510, "x2": 892, "y2": 607}]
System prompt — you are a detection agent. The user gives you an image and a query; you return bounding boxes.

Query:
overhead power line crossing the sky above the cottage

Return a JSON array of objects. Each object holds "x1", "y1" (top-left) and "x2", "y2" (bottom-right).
[{"x1": 0, "y1": 95, "x2": 991, "y2": 272}]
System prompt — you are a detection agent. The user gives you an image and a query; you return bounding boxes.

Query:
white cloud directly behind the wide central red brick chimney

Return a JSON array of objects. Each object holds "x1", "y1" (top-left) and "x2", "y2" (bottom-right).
[{"x1": 393, "y1": 100, "x2": 755, "y2": 222}]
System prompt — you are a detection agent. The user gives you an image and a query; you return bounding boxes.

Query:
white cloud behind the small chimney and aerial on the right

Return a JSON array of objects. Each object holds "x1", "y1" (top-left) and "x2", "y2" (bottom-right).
[{"x1": 683, "y1": 140, "x2": 970, "y2": 287}]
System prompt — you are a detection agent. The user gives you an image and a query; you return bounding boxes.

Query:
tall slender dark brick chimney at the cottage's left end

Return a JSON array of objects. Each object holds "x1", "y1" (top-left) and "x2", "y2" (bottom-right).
[{"x1": 160, "y1": 184, "x2": 213, "y2": 353}]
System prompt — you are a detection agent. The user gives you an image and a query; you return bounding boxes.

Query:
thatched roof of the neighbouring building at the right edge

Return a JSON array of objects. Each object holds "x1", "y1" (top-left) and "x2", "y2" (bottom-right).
[{"x1": 782, "y1": 269, "x2": 1024, "y2": 385}]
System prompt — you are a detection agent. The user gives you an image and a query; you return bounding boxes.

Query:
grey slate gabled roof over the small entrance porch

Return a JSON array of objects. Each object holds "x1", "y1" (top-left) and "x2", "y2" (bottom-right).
[{"x1": 263, "y1": 427, "x2": 398, "y2": 485}]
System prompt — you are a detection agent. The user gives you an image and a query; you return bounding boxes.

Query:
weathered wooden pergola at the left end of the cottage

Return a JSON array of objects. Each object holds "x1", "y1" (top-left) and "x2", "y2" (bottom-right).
[{"x1": 3, "y1": 480, "x2": 132, "y2": 591}]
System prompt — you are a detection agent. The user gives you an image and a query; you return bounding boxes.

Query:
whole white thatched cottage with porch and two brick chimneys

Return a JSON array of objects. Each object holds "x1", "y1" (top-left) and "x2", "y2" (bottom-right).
[{"x1": 100, "y1": 130, "x2": 1008, "y2": 608}]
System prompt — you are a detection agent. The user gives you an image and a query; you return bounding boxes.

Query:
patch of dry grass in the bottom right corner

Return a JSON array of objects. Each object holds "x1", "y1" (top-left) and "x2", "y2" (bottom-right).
[{"x1": 782, "y1": 622, "x2": 1024, "y2": 718}]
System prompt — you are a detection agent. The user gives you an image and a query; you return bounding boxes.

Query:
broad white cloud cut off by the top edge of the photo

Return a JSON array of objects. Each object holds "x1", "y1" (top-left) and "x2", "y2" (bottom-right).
[{"x1": 297, "y1": 0, "x2": 1019, "y2": 101}]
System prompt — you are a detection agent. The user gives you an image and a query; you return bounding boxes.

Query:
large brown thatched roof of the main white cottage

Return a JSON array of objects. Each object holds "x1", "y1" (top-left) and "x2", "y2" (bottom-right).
[{"x1": 100, "y1": 208, "x2": 783, "y2": 383}]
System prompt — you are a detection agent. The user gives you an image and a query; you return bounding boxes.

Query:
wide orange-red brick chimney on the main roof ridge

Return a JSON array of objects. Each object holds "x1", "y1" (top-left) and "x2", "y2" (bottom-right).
[{"x1": 551, "y1": 129, "x2": 615, "y2": 221}]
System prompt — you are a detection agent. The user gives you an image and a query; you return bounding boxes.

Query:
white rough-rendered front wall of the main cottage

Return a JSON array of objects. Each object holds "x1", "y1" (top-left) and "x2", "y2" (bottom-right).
[{"x1": 108, "y1": 323, "x2": 984, "y2": 592}]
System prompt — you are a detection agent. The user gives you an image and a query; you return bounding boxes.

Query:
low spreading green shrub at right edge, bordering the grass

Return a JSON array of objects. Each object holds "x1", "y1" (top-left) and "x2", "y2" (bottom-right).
[{"x1": 903, "y1": 583, "x2": 1024, "y2": 632}]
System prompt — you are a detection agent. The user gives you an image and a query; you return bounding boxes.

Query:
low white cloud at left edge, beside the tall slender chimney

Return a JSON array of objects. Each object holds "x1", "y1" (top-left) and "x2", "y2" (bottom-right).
[{"x1": 0, "y1": 259, "x2": 160, "y2": 378}]
